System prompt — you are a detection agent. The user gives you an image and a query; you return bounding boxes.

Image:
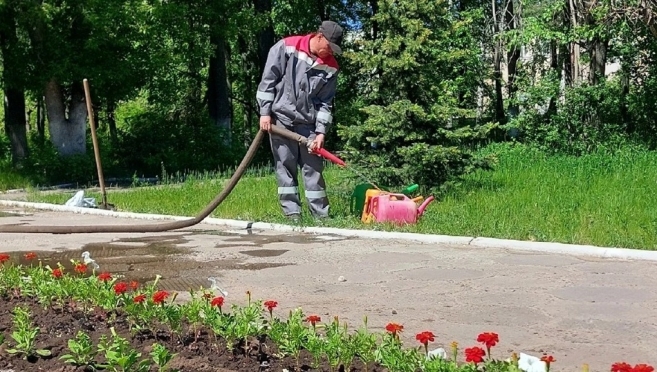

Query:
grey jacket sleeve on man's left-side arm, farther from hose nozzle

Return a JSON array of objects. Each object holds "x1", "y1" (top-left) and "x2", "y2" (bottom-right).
[{"x1": 256, "y1": 40, "x2": 287, "y2": 116}]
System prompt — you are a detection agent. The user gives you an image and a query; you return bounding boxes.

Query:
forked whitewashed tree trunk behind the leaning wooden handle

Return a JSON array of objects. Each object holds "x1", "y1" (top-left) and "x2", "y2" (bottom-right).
[{"x1": 45, "y1": 79, "x2": 87, "y2": 156}]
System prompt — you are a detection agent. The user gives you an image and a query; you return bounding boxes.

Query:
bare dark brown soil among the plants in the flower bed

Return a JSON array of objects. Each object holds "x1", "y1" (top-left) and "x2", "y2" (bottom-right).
[{"x1": 0, "y1": 298, "x2": 385, "y2": 372}]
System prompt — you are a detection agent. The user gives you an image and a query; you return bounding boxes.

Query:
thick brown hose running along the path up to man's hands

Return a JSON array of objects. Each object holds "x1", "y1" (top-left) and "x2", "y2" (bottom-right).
[{"x1": 0, "y1": 125, "x2": 309, "y2": 234}]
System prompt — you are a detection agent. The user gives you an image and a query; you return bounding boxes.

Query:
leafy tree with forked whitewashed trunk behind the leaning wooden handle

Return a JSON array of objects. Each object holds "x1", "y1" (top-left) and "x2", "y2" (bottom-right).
[{"x1": 4, "y1": 0, "x2": 154, "y2": 156}]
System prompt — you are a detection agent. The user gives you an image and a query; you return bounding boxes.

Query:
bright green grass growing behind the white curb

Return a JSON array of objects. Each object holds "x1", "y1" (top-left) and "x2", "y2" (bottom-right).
[{"x1": 25, "y1": 142, "x2": 657, "y2": 249}]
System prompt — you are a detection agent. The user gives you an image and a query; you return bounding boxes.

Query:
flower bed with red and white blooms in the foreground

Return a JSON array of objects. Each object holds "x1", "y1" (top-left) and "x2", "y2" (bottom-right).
[{"x1": 0, "y1": 253, "x2": 653, "y2": 372}]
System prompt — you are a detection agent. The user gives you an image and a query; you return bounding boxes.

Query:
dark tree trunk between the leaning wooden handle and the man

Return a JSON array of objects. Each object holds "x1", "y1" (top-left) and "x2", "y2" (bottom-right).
[{"x1": 207, "y1": 35, "x2": 232, "y2": 144}]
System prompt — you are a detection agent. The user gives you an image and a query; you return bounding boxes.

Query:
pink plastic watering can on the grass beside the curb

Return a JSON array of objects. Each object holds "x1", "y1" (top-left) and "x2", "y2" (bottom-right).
[{"x1": 370, "y1": 194, "x2": 434, "y2": 225}]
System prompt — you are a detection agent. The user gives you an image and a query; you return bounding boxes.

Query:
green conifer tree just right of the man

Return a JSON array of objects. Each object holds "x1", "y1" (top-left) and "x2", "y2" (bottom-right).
[{"x1": 339, "y1": 0, "x2": 495, "y2": 187}]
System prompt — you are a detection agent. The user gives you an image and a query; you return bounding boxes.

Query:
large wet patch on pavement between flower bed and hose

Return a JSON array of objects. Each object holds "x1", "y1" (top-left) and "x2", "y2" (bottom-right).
[{"x1": 6, "y1": 230, "x2": 348, "y2": 291}]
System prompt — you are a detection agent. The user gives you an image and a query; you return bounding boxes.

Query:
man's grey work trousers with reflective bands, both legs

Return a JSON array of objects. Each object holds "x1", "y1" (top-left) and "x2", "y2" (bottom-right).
[{"x1": 269, "y1": 118, "x2": 329, "y2": 218}]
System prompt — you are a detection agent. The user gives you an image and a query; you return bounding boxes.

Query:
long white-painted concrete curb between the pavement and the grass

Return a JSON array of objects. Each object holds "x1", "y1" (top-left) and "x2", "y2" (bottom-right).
[{"x1": 0, "y1": 200, "x2": 657, "y2": 261}]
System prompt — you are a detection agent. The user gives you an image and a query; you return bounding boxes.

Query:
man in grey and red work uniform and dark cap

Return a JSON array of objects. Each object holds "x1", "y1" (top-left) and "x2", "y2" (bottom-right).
[{"x1": 256, "y1": 21, "x2": 343, "y2": 220}]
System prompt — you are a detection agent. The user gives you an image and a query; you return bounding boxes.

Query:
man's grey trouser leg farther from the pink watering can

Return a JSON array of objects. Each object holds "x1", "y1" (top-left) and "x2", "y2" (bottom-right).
[{"x1": 269, "y1": 123, "x2": 301, "y2": 216}]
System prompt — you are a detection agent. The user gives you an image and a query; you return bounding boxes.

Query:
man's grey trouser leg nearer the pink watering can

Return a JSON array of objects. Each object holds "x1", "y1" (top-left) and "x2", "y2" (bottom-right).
[{"x1": 299, "y1": 140, "x2": 329, "y2": 217}]
